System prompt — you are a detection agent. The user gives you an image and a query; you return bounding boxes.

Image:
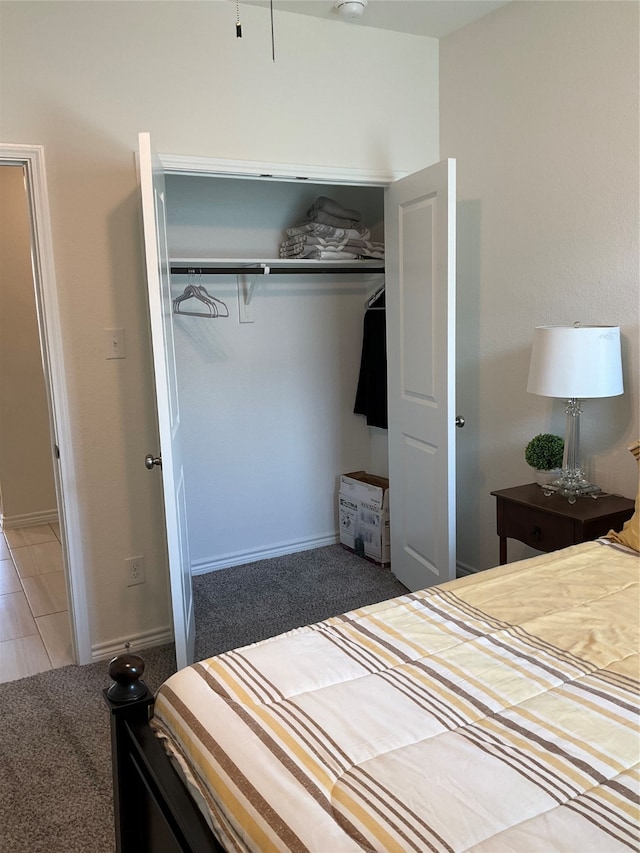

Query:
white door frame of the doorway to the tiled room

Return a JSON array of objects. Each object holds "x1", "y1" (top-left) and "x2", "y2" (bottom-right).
[{"x1": 0, "y1": 143, "x2": 92, "y2": 664}]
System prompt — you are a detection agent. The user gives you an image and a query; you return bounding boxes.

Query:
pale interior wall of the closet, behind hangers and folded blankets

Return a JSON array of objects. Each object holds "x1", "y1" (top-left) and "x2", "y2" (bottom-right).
[{"x1": 166, "y1": 174, "x2": 388, "y2": 573}]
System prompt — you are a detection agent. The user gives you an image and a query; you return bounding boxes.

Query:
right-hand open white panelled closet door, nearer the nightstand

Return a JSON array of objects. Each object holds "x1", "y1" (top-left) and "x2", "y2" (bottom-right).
[{"x1": 385, "y1": 160, "x2": 456, "y2": 590}]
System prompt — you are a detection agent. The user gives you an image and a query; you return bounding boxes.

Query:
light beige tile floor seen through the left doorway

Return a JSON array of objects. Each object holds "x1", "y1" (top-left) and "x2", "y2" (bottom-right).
[{"x1": 0, "y1": 524, "x2": 73, "y2": 682}]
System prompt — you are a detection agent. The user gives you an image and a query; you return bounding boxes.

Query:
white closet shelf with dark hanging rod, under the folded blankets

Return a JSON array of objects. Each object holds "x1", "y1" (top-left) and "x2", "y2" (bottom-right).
[{"x1": 170, "y1": 258, "x2": 384, "y2": 275}]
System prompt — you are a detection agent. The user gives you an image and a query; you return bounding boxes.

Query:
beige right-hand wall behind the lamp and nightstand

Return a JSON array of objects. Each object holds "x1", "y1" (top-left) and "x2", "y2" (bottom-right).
[{"x1": 440, "y1": 0, "x2": 640, "y2": 568}]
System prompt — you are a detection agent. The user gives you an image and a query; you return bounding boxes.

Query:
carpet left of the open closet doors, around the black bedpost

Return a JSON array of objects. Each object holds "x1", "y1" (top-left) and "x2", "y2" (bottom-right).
[{"x1": 0, "y1": 645, "x2": 175, "y2": 853}]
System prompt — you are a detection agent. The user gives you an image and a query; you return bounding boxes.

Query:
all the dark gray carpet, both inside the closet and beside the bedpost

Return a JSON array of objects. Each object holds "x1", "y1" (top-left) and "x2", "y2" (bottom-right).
[{"x1": 0, "y1": 546, "x2": 405, "y2": 853}]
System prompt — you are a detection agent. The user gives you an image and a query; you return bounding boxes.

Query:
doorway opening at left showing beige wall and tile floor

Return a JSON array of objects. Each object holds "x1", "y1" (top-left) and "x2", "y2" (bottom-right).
[{"x1": 0, "y1": 165, "x2": 74, "y2": 681}]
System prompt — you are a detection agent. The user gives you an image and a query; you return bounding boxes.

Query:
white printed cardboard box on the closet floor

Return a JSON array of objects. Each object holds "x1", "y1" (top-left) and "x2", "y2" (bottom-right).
[{"x1": 338, "y1": 471, "x2": 391, "y2": 566}]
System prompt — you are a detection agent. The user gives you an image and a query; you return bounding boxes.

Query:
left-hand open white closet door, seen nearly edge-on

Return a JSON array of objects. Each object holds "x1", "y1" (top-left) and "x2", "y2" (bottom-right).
[{"x1": 138, "y1": 133, "x2": 195, "y2": 668}]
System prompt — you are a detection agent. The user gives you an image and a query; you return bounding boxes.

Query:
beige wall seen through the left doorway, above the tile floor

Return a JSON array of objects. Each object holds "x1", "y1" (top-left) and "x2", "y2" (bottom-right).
[{"x1": 0, "y1": 166, "x2": 57, "y2": 528}]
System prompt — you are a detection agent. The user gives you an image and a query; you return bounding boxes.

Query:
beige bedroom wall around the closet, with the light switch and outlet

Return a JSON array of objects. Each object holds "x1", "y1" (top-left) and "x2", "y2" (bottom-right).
[{"x1": 0, "y1": 0, "x2": 438, "y2": 653}]
